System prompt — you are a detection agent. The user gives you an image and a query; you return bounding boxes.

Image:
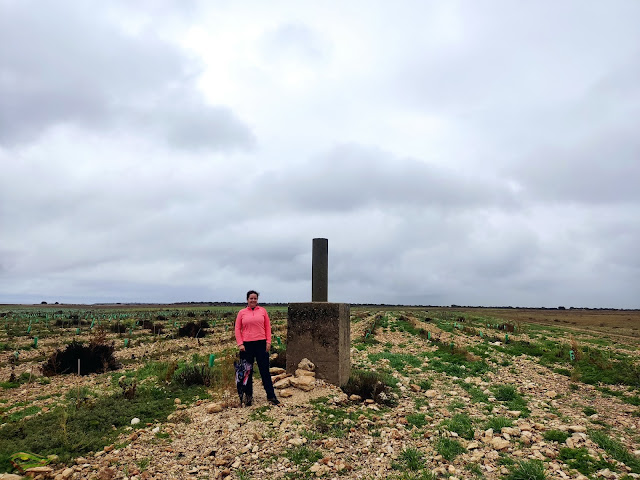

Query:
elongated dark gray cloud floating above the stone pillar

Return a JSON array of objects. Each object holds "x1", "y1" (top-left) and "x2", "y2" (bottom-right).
[{"x1": 259, "y1": 145, "x2": 518, "y2": 211}]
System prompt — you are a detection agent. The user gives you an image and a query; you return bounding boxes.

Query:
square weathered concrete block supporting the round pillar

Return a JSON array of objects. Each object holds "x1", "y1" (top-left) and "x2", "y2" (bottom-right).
[{"x1": 287, "y1": 302, "x2": 351, "y2": 386}]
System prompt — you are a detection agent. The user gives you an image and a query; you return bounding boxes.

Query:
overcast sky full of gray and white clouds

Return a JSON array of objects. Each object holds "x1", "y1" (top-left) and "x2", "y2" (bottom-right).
[{"x1": 0, "y1": 0, "x2": 640, "y2": 308}]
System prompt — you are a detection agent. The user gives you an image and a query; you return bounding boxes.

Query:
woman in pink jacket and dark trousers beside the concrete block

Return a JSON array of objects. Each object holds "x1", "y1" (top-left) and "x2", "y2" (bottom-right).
[{"x1": 236, "y1": 290, "x2": 280, "y2": 406}]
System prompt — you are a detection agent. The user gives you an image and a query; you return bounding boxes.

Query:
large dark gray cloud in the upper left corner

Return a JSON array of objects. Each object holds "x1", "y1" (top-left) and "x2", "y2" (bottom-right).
[{"x1": 0, "y1": 2, "x2": 254, "y2": 150}]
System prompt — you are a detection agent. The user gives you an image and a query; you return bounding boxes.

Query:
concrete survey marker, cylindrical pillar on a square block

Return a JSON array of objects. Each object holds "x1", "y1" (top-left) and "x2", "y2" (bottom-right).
[{"x1": 287, "y1": 238, "x2": 351, "y2": 386}]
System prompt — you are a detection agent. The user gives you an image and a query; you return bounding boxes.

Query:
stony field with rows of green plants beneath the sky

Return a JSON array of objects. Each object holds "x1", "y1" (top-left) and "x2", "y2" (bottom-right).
[{"x1": 0, "y1": 305, "x2": 640, "y2": 480}]
